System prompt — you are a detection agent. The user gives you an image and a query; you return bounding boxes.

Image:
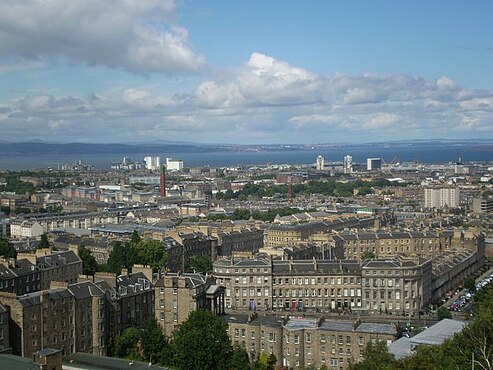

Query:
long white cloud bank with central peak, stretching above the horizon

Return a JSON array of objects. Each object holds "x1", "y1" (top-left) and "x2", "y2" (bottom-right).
[{"x1": 0, "y1": 53, "x2": 493, "y2": 143}]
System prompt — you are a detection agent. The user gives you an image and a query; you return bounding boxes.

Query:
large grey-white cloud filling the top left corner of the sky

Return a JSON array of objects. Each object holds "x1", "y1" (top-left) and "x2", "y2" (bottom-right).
[{"x1": 0, "y1": 0, "x2": 205, "y2": 73}]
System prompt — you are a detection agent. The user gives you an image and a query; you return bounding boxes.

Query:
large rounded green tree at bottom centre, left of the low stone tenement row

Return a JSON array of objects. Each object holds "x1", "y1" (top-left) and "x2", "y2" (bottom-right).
[{"x1": 172, "y1": 310, "x2": 232, "y2": 370}]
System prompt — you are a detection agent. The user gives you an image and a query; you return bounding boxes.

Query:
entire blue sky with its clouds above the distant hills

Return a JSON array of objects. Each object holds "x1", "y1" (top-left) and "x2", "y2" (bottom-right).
[{"x1": 0, "y1": 0, "x2": 493, "y2": 144}]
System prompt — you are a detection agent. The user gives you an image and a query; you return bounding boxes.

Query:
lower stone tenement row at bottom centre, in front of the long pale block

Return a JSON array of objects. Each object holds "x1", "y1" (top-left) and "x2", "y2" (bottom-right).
[{"x1": 225, "y1": 314, "x2": 398, "y2": 369}]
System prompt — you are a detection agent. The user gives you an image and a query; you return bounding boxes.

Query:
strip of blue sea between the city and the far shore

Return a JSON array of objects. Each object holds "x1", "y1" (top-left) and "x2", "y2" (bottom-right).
[{"x1": 0, "y1": 144, "x2": 493, "y2": 171}]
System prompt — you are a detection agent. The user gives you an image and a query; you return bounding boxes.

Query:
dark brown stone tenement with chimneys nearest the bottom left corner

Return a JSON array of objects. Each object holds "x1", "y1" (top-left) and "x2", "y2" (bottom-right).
[{"x1": 0, "y1": 282, "x2": 106, "y2": 357}]
